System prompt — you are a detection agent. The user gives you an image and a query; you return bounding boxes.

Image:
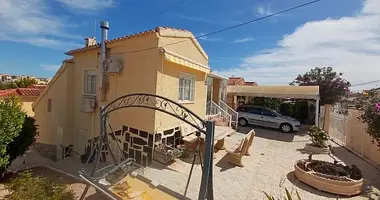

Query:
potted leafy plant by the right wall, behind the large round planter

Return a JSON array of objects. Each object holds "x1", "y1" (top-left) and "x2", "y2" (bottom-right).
[{"x1": 304, "y1": 126, "x2": 330, "y2": 154}]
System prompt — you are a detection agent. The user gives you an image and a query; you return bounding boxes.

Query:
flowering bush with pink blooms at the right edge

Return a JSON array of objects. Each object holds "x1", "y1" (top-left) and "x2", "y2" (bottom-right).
[{"x1": 357, "y1": 90, "x2": 380, "y2": 148}]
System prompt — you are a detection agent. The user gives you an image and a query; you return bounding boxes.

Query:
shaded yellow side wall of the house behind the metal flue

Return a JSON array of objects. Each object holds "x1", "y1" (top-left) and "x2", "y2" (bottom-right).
[{"x1": 68, "y1": 34, "x2": 161, "y2": 153}]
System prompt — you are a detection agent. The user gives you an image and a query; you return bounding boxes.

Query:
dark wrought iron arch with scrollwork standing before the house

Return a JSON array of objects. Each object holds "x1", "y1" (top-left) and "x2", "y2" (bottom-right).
[{"x1": 80, "y1": 93, "x2": 215, "y2": 200}]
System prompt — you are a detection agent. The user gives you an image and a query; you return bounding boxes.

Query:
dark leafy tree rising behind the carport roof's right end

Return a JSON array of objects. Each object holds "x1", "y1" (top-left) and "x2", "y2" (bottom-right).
[{"x1": 290, "y1": 67, "x2": 351, "y2": 105}]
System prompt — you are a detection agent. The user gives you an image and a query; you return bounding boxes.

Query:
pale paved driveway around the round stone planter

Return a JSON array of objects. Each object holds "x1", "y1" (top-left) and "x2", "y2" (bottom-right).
[{"x1": 144, "y1": 128, "x2": 380, "y2": 200}]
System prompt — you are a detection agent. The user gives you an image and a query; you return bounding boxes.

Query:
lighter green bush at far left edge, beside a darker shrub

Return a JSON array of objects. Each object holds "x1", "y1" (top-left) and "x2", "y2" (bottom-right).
[{"x1": 0, "y1": 96, "x2": 26, "y2": 169}]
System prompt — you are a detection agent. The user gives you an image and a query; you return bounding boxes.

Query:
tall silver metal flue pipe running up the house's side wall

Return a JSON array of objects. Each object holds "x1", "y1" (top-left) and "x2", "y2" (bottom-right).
[{"x1": 99, "y1": 21, "x2": 110, "y2": 96}]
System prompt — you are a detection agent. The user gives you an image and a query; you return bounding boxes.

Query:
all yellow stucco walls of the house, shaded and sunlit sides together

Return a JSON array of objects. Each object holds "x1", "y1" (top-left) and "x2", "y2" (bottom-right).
[{"x1": 35, "y1": 30, "x2": 207, "y2": 155}]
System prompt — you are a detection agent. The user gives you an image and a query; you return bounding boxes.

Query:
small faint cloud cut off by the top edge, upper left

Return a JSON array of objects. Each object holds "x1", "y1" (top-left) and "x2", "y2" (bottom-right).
[{"x1": 56, "y1": 0, "x2": 114, "y2": 10}]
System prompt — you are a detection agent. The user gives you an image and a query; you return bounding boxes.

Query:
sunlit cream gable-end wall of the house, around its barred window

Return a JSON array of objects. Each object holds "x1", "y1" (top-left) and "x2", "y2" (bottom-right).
[{"x1": 155, "y1": 37, "x2": 208, "y2": 131}]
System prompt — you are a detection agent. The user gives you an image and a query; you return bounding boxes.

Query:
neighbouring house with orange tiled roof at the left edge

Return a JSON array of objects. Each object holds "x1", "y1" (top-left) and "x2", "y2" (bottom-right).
[{"x1": 0, "y1": 85, "x2": 46, "y2": 117}]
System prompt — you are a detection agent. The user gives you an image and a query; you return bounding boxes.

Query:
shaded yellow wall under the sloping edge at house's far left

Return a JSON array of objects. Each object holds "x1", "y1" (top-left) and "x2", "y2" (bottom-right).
[{"x1": 34, "y1": 63, "x2": 73, "y2": 144}]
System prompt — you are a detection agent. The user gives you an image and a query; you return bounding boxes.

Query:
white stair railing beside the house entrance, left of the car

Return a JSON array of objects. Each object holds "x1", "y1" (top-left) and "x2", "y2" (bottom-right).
[{"x1": 206, "y1": 101, "x2": 232, "y2": 127}]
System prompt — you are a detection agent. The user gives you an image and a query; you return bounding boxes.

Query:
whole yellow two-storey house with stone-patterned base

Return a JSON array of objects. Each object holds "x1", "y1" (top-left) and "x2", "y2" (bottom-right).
[{"x1": 33, "y1": 27, "x2": 230, "y2": 165}]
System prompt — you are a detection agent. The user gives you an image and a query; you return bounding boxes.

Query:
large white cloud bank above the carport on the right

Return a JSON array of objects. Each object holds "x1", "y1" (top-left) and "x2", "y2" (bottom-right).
[{"x1": 221, "y1": 0, "x2": 380, "y2": 88}]
